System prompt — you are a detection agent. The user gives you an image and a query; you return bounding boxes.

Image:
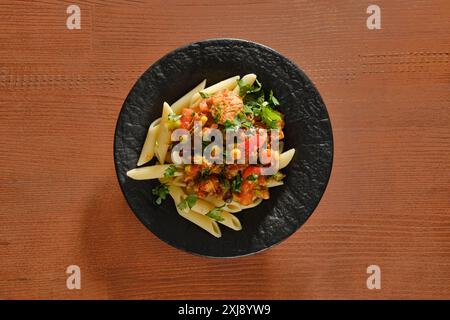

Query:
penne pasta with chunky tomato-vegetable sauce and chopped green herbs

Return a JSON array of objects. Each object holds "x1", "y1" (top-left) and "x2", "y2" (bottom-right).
[{"x1": 127, "y1": 74, "x2": 295, "y2": 238}]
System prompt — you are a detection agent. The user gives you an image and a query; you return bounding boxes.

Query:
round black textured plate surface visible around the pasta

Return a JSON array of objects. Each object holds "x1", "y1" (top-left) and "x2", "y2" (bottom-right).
[{"x1": 114, "y1": 39, "x2": 333, "y2": 257}]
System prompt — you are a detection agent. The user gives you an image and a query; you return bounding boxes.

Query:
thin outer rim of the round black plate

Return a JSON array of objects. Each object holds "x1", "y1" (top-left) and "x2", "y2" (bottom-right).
[{"x1": 113, "y1": 38, "x2": 334, "y2": 259}]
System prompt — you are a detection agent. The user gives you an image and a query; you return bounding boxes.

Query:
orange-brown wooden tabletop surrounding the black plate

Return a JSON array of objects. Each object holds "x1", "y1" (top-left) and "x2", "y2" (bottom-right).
[{"x1": 0, "y1": 0, "x2": 450, "y2": 299}]
